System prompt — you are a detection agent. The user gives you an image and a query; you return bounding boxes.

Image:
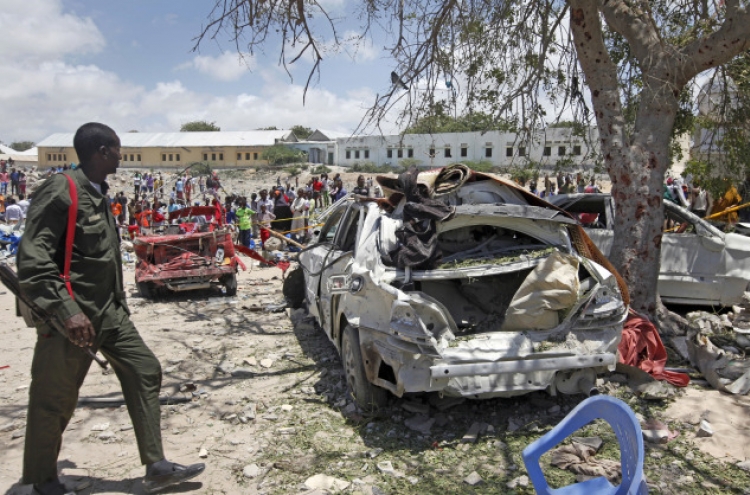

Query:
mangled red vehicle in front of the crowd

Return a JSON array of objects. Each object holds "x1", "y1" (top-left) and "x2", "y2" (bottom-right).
[{"x1": 133, "y1": 206, "x2": 239, "y2": 298}]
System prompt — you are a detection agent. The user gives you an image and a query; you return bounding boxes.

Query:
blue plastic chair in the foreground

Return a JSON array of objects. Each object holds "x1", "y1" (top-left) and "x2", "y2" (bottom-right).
[{"x1": 523, "y1": 395, "x2": 648, "y2": 495}]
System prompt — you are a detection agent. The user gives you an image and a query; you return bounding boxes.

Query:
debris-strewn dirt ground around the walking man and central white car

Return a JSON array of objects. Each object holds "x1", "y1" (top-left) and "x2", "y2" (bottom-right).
[{"x1": 0, "y1": 168, "x2": 750, "y2": 495}]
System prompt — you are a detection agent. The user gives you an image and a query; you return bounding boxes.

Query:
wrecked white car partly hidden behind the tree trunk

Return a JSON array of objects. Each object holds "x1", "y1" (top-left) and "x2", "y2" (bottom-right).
[{"x1": 550, "y1": 194, "x2": 750, "y2": 306}]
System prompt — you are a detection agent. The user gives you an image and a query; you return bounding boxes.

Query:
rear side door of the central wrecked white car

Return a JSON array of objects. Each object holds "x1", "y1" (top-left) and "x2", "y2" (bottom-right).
[{"x1": 319, "y1": 203, "x2": 364, "y2": 343}]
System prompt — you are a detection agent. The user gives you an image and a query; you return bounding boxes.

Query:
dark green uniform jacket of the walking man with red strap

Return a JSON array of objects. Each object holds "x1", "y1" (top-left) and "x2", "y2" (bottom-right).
[{"x1": 18, "y1": 168, "x2": 129, "y2": 330}]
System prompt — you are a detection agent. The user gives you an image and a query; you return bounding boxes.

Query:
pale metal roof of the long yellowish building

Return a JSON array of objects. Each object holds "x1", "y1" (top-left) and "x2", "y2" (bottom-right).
[{"x1": 37, "y1": 130, "x2": 296, "y2": 148}]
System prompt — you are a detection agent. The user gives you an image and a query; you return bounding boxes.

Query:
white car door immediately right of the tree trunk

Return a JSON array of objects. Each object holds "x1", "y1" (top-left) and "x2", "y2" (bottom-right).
[{"x1": 658, "y1": 202, "x2": 725, "y2": 304}]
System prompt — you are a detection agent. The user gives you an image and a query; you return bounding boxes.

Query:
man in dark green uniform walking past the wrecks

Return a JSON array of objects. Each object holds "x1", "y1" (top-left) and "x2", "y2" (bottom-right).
[{"x1": 18, "y1": 123, "x2": 205, "y2": 495}]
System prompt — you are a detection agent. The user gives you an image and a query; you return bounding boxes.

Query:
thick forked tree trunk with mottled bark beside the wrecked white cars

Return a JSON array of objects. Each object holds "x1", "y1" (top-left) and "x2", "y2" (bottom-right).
[{"x1": 569, "y1": 0, "x2": 750, "y2": 321}]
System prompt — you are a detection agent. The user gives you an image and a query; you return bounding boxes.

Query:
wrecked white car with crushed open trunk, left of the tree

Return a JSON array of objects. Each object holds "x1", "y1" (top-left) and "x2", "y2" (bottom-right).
[{"x1": 299, "y1": 166, "x2": 627, "y2": 410}]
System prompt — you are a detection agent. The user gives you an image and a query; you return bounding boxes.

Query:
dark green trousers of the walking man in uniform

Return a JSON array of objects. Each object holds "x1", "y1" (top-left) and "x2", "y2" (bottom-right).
[{"x1": 23, "y1": 304, "x2": 164, "y2": 484}]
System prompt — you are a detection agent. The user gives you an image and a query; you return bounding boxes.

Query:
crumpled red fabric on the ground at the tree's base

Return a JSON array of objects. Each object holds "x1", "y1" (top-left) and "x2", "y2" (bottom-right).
[{"x1": 617, "y1": 313, "x2": 690, "y2": 387}]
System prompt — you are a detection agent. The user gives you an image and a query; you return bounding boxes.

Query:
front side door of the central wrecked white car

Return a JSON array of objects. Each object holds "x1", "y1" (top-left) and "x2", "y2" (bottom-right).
[{"x1": 299, "y1": 203, "x2": 348, "y2": 328}]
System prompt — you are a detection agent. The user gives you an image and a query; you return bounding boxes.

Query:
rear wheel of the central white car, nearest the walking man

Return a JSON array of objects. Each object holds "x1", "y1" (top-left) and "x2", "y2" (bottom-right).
[{"x1": 341, "y1": 324, "x2": 388, "y2": 413}]
